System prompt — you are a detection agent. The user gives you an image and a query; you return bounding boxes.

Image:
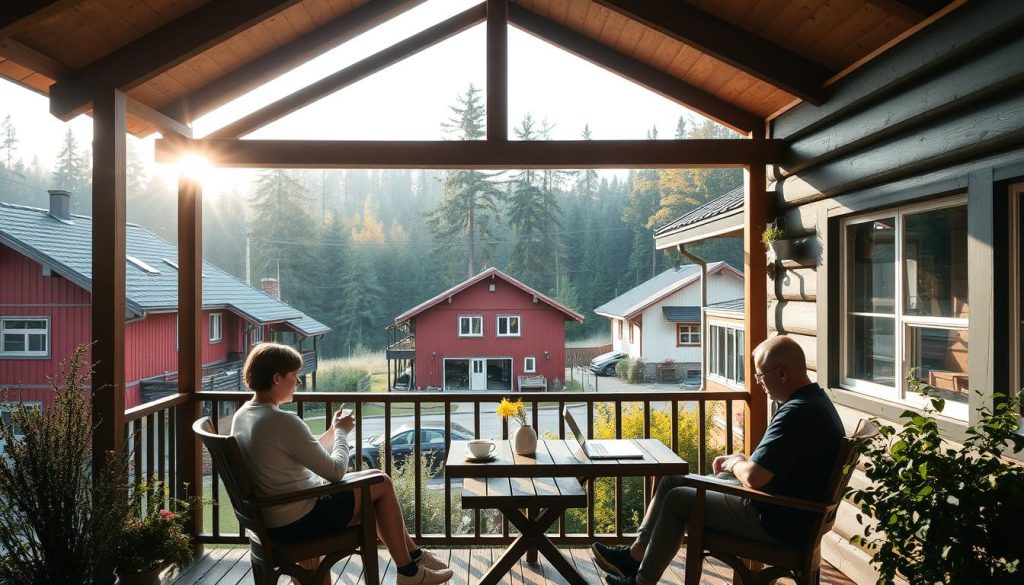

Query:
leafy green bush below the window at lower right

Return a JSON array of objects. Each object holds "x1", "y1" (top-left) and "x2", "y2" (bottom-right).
[{"x1": 852, "y1": 373, "x2": 1024, "y2": 585}]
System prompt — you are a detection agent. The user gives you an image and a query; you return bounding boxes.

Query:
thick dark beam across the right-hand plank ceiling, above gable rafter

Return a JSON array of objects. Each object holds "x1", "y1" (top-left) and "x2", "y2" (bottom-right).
[{"x1": 594, "y1": 0, "x2": 833, "y2": 106}]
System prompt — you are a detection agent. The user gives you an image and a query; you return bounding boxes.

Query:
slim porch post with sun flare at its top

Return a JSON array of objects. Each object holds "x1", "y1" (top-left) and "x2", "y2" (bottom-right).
[{"x1": 175, "y1": 174, "x2": 201, "y2": 552}]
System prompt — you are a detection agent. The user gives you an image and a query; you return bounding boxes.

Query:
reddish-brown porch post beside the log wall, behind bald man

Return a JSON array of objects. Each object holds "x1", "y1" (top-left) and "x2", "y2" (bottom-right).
[{"x1": 743, "y1": 133, "x2": 773, "y2": 455}]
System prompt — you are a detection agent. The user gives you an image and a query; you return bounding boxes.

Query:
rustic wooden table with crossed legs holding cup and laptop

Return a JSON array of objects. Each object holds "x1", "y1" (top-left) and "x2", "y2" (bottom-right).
[{"x1": 444, "y1": 438, "x2": 689, "y2": 585}]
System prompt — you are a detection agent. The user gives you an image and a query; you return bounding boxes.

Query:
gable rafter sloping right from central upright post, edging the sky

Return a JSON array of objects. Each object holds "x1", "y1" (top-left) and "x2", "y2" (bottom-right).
[{"x1": 509, "y1": 4, "x2": 765, "y2": 134}]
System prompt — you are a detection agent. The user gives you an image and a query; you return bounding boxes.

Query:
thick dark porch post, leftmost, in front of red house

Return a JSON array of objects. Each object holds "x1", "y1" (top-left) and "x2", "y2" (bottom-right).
[{"x1": 91, "y1": 89, "x2": 127, "y2": 473}]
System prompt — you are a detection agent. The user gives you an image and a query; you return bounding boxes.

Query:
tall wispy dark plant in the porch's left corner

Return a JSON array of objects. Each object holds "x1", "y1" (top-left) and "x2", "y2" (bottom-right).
[{"x1": 0, "y1": 345, "x2": 130, "y2": 584}]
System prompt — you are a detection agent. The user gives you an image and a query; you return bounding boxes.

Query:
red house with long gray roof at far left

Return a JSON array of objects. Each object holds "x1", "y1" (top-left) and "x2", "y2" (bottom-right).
[{"x1": 0, "y1": 192, "x2": 330, "y2": 409}]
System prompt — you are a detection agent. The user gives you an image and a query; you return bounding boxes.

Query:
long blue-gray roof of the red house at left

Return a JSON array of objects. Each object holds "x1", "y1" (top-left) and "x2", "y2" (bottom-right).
[{"x1": 0, "y1": 202, "x2": 331, "y2": 335}]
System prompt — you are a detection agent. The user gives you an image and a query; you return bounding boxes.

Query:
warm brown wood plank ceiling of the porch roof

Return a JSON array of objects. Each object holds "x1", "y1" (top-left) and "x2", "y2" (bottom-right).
[{"x1": 0, "y1": 0, "x2": 942, "y2": 135}]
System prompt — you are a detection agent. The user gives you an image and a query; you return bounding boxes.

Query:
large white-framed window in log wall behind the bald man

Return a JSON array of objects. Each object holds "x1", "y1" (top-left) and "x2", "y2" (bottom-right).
[{"x1": 842, "y1": 197, "x2": 970, "y2": 419}]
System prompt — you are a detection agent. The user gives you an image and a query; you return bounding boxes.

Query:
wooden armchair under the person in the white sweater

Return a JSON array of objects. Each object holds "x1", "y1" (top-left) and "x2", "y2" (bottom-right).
[{"x1": 193, "y1": 417, "x2": 384, "y2": 585}]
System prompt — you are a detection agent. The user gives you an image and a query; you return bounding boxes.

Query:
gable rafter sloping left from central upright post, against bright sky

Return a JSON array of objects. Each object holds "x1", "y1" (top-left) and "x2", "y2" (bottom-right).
[{"x1": 208, "y1": 3, "x2": 487, "y2": 138}]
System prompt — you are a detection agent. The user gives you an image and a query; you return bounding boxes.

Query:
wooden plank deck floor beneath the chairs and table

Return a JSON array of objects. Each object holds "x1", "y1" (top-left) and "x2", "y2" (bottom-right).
[{"x1": 165, "y1": 547, "x2": 853, "y2": 585}]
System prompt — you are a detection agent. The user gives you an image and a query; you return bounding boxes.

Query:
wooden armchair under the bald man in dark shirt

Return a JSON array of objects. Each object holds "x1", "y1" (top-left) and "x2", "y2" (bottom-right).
[{"x1": 685, "y1": 420, "x2": 878, "y2": 585}]
